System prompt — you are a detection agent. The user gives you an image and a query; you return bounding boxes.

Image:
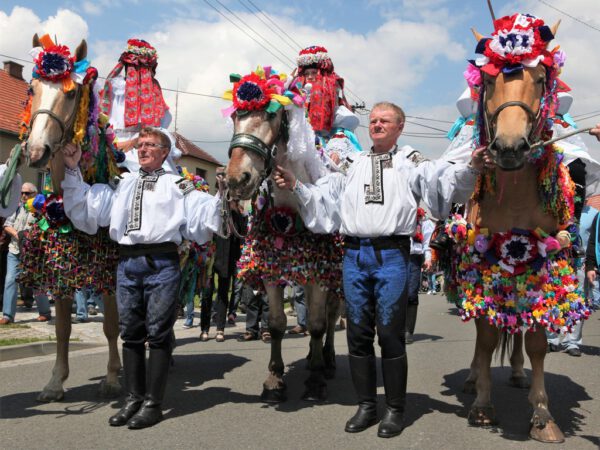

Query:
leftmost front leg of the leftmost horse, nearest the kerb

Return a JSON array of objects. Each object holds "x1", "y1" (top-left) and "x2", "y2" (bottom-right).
[{"x1": 37, "y1": 298, "x2": 71, "y2": 402}]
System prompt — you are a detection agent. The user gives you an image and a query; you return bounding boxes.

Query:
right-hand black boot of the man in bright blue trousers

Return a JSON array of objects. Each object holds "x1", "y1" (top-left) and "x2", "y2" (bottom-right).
[{"x1": 377, "y1": 354, "x2": 408, "y2": 438}]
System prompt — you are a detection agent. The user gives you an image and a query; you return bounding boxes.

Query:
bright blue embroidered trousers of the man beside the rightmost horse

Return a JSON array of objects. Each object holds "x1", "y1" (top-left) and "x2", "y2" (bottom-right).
[{"x1": 343, "y1": 243, "x2": 408, "y2": 358}]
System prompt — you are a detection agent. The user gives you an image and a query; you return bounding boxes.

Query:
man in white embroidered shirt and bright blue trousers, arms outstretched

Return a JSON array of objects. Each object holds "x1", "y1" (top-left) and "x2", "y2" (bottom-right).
[{"x1": 274, "y1": 102, "x2": 491, "y2": 438}]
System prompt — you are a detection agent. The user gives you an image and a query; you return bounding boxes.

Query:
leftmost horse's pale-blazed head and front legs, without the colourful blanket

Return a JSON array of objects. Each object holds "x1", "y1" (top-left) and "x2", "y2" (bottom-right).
[{"x1": 25, "y1": 34, "x2": 122, "y2": 402}]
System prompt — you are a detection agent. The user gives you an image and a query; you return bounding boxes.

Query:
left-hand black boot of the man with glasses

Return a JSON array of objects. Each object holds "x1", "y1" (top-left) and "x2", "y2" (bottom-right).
[{"x1": 108, "y1": 344, "x2": 146, "y2": 427}]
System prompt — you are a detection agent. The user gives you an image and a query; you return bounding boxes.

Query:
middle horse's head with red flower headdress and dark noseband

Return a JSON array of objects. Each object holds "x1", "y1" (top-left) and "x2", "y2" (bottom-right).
[{"x1": 225, "y1": 67, "x2": 294, "y2": 200}]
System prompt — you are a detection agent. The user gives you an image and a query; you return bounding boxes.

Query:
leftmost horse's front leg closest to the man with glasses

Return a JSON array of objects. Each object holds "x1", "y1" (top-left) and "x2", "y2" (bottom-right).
[{"x1": 98, "y1": 295, "x2": 122, "y2": 398}]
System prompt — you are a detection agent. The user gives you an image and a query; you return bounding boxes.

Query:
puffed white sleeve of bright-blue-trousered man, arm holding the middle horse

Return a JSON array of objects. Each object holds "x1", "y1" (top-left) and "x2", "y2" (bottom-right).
[{"x1": 294, "y1": 173, "x2": 346, "y2": 234}]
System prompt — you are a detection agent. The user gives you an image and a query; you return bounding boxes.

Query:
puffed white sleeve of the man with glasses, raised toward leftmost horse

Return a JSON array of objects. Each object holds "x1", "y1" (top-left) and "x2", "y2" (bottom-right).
[{"x1": 61, "y1": 167, "x2": 115, "y2": 234}]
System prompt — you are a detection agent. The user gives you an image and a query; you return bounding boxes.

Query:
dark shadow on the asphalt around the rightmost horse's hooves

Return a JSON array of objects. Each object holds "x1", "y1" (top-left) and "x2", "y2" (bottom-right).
[{"x1": 442, "y1": 367, "x2": 598, "y2": 442}]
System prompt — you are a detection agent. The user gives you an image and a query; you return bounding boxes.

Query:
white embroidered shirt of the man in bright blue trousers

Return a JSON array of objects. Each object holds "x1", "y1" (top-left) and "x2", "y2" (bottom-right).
[{"x1": 294, "y1": 146, "x2": 476, "y2": 238}]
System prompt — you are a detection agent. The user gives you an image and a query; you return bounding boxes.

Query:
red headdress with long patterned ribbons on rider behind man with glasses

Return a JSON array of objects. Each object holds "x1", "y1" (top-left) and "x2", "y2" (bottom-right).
[{"x1": 101, "y1": 39, "x2": 169, "y2": 128}]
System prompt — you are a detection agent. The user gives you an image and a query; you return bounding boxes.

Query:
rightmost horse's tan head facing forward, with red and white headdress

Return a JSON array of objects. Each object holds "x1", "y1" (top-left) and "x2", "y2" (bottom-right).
[{"x1": 473, "y1": 15, "x2": 559, "y2": 171}]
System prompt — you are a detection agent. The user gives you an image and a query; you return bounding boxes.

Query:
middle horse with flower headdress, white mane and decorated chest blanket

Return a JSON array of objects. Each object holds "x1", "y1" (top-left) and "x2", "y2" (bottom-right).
[{"x1": 226, "y1": 68, "x2": 341, "y2": 403}]
